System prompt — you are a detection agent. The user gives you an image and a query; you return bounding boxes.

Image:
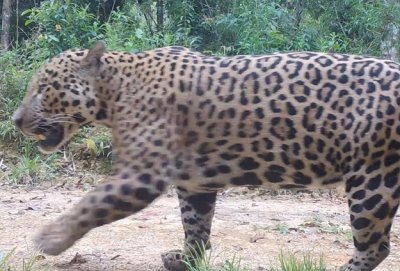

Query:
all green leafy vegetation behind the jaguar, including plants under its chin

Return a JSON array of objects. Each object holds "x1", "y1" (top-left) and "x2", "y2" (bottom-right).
[{"x1": 0, "y1": 0, "x2": 400, "y2": 183}]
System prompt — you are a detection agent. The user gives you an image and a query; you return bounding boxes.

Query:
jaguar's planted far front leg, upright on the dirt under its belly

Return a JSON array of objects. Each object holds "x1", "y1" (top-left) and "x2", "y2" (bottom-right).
[{"x1": 161, "y1": 187, "x2": 217, "y2": 271}]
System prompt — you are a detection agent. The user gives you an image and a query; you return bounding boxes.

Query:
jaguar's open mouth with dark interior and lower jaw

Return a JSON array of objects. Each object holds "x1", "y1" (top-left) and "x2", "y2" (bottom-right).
[{"x1": 35, "y1": 125, "x2": 64, "y2": 152}]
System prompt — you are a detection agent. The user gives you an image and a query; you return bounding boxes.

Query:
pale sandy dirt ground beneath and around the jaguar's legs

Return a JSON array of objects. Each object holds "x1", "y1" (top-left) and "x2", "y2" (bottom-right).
[{"x1": 0, "y1": 186, "x2": 400, "y2": 271}]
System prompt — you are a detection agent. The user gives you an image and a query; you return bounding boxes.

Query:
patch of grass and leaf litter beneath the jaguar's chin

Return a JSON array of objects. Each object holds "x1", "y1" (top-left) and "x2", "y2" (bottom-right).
[{"x1": 0, "y1": 124, "x2": 112, "y2": 185}]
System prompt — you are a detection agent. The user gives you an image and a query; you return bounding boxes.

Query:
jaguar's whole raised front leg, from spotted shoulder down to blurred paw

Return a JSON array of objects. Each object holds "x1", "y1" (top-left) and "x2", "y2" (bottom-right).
[{"x1": 35, "y1": 116, "x2": 179, "y2": 255}]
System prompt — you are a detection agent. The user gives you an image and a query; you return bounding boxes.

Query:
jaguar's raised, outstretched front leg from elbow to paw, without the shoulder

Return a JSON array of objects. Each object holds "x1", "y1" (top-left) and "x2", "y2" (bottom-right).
[{"x1": 34, "y1": 175, "x2": 165, "y2": 255}]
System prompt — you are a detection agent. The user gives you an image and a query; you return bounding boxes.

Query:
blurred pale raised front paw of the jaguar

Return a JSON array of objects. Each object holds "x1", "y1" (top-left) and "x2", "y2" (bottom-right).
[{"x1": 33, "y1": 219, "x2": 82, "y2": 255}]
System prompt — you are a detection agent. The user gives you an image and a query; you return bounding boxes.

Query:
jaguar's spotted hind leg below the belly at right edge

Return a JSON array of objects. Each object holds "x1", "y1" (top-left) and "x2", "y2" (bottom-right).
[{"x1": 341, "y1": 173, "x2": 400, "y2": 271}]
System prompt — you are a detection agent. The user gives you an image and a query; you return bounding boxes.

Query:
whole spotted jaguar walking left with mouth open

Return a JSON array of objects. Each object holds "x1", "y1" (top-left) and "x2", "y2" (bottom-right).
[{"x1": 13, "y1": 42, "x2": 400, "y2": 271}]
